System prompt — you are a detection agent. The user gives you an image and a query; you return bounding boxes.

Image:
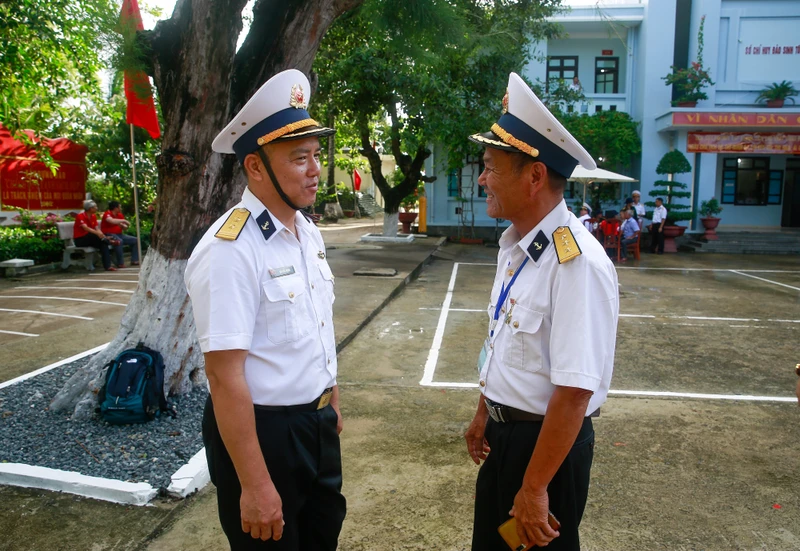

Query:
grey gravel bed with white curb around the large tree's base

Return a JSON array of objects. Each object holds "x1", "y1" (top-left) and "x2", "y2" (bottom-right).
[{"x1": 0, "y1": 357, "x2": 208, "y2": 494}]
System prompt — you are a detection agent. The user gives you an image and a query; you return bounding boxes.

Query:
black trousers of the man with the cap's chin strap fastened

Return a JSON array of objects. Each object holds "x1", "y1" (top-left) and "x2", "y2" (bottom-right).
[{"x1": 203, "y1": 396, "x2": 346, "y2": 551}]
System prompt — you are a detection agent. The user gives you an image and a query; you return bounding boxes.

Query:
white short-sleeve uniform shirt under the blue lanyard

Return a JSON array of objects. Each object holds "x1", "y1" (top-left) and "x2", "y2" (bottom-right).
[{"x1": 479, "y1": 201, "x2": 619, "y2": 415}]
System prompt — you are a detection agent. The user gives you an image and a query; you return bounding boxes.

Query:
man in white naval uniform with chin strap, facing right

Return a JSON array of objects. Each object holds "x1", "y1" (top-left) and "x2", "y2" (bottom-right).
[{"x1": 185, "y1": 70, "x2": 345, "y2": 551}]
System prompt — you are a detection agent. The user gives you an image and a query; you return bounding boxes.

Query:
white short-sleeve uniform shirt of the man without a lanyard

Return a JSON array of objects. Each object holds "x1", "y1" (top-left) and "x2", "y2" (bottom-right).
[{"x1": 184, "y1": 188, "x2": 337, "y2": 406}]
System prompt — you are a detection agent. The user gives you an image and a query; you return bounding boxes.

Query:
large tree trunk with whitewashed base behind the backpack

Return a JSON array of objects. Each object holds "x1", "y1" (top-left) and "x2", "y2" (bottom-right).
[{"x1": 52, "y1": 0, "x2": 363, "y2": 418}]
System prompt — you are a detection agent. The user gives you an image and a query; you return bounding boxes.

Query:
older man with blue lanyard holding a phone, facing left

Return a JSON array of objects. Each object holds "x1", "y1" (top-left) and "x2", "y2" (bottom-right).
[{"x1": 465, "y1": 73, "x2": 619, "y2": 551}]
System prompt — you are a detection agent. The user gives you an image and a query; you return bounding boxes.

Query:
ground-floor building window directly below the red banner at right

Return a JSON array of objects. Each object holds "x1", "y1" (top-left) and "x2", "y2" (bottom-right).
[{"x1": 722, "y1": 157, "x2": 783, "y2": 205}]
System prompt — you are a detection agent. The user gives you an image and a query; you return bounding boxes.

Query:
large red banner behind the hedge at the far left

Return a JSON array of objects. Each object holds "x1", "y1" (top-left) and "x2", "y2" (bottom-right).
[{"x1": 0, "y1": 126, "x2": 88, "y2": 210}]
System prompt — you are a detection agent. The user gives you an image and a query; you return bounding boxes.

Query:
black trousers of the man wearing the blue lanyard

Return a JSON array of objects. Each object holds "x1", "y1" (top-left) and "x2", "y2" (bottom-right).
[{"x1": 472, "y1": 417, "x2": 594, "y2": 551}]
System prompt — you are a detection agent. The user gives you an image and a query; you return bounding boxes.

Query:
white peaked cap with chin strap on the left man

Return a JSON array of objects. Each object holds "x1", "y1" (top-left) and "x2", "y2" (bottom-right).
[{"x1": 211, "y1": 69, "x2": 334, "y2": 162}]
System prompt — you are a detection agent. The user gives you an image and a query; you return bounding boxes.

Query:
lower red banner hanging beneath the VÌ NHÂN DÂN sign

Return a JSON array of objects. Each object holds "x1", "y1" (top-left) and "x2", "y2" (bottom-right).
[{"x1": 686, "y1": 132, "x2": 800, "y2": 155}]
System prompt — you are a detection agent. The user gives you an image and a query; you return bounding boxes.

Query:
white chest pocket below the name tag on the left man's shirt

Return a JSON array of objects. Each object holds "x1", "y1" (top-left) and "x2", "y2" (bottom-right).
[{"x1": 262, "y1": 275, "x2": 312, "y2": 344}]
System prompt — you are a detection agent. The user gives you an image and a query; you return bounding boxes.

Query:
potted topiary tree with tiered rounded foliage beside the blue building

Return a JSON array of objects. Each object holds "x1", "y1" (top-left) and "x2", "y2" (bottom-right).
[{"x1": 645, "y1": 149, "x2": 693, "y2": 253}]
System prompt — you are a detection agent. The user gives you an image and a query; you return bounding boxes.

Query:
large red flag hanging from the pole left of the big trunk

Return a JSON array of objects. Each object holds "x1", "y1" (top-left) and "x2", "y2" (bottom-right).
[{"x1": 119, "y1": 0, "x2": 161, "y2": 139}]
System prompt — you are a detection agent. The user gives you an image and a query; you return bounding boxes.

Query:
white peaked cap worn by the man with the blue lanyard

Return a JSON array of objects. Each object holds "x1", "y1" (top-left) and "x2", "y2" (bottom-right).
[{"x1": 470, "y1": 73, "x2": 597, "y2": 178}]
